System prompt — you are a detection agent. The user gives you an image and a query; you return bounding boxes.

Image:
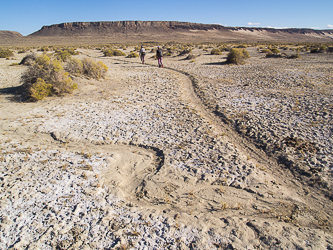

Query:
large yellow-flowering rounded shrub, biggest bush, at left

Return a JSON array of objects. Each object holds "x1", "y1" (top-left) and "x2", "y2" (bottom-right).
[{"x1": 21, "y1": 55, "x2": 77, "y2": 101}]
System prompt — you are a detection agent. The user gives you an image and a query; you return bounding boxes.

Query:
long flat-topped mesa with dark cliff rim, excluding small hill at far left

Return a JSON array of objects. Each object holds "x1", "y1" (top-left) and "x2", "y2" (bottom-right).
[{"x1": 29, "y1": 21, "x2": 333, "y2": 41}]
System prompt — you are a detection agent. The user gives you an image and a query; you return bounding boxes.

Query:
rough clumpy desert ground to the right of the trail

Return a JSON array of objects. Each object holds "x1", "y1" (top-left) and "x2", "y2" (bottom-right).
[{"x1": 172, "y1": 49, "x2": 333, "y2": 190}]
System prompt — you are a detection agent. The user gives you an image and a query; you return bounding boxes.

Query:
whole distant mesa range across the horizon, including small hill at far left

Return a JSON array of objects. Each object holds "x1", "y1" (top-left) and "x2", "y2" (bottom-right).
[{"x1": 0, "y1": 21, "x2": 333, "y2": 45}]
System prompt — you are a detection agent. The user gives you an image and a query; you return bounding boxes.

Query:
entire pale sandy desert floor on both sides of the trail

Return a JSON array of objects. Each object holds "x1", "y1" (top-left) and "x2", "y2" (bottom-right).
[{"x1": 0, "y1": 48, "x2": 333, "y2": 249}]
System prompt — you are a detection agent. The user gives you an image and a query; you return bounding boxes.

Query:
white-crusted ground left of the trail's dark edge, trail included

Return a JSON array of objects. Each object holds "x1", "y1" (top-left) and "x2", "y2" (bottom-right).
[{"x1": 0, "y1": 51, "x2": 332, "y2": 249}]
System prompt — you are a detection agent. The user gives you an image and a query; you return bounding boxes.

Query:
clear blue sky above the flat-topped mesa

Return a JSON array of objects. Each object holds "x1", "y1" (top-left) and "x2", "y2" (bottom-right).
[{"x1": 0, "y1": 0, "x2": 333, "y2": 35}]
